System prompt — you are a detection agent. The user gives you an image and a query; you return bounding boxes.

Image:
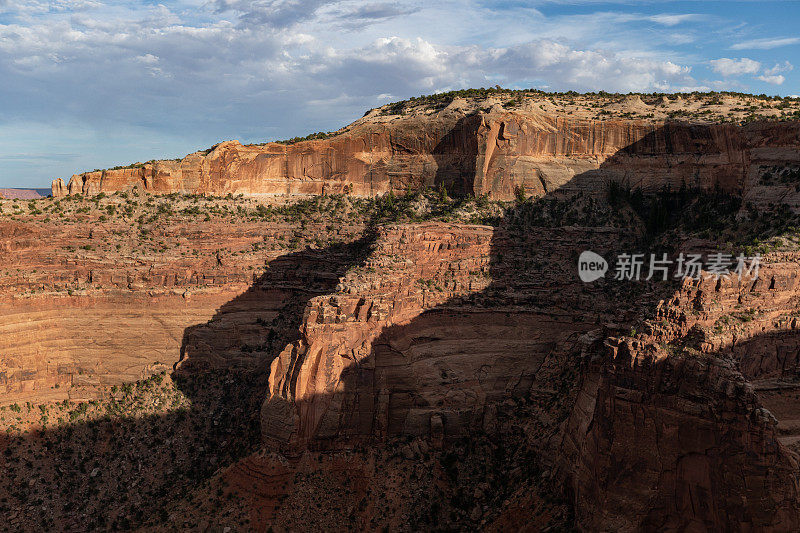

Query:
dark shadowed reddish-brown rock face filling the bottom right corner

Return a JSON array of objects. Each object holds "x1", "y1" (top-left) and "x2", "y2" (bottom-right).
[{"x1": 569, "y1": 338, "x2": 800, "y2": 531}]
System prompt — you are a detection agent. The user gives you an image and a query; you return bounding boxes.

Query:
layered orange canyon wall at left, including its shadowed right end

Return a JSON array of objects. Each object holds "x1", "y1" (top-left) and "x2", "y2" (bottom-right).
[{"x1": 0, "y1": 210, "x2": 361, "y2": 404}]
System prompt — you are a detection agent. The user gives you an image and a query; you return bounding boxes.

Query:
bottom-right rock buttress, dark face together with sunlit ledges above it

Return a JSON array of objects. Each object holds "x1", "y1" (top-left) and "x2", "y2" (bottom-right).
[{"x1": 564, "y1": 260, "x2": 800, "y2": 531}]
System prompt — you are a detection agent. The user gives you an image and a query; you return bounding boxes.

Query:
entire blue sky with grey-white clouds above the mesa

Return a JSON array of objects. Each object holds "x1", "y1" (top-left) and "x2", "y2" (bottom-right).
[{"x1": 0, "y1": 0, "x2": 800, "y2": 187}]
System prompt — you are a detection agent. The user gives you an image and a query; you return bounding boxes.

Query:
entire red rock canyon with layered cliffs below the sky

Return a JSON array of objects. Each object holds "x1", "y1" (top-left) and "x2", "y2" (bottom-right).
[{"x1": 0, "y1": 90, "x2": 800, "y2": 531}]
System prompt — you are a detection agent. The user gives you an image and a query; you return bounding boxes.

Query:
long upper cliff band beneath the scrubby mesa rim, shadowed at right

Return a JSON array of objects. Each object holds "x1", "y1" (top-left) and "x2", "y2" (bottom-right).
[{"x1": 53, "y1": 106, "x2": 800, "y2": 200}]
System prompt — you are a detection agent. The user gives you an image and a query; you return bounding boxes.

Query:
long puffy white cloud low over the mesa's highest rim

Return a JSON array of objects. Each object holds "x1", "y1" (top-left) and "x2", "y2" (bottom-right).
[{"x1": 302, "y1": 37, "x2": 695, "y2": 98}]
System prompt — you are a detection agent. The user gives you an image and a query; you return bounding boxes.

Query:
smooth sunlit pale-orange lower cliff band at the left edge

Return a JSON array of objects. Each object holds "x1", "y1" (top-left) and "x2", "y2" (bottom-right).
[{"x1": 0, "y1": 291, "x2": 231, "y2": 403}]
